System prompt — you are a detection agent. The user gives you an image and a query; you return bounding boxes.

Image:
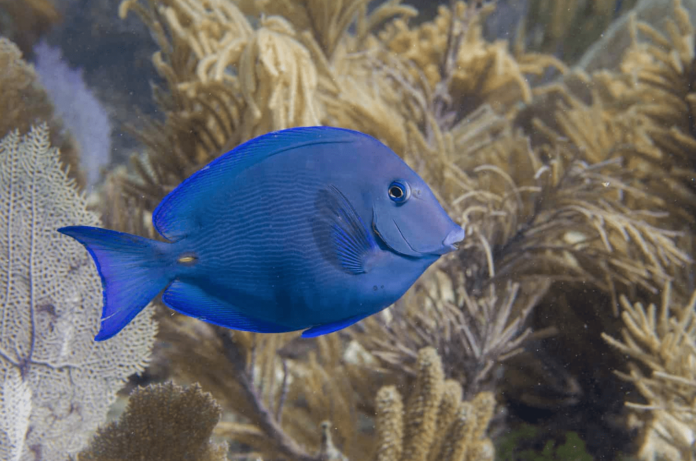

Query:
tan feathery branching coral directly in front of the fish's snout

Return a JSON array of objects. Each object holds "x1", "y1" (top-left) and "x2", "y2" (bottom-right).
[{"x1": 354, "y1": 101, "x2": 689, "y2": 394}]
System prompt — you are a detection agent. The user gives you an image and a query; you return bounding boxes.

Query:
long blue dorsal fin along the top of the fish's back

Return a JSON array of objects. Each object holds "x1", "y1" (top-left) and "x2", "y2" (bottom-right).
[{"x1": 152, "y1": 126, "x2": 367, "y2": 240}]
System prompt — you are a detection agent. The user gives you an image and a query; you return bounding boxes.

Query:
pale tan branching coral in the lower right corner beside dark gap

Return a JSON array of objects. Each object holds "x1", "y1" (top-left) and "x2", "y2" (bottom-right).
[{"x1": 602, "y1": 284, "x2": 696, "y2": 460}]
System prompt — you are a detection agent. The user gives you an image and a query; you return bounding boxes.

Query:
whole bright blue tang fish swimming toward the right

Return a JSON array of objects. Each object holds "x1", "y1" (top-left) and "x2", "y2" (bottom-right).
[{"x1": 58, "y1": 127, "x2": 464, "y2": 341}]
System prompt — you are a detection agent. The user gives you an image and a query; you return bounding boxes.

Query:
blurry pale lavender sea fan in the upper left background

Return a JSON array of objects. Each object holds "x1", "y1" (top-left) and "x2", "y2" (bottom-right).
[{"x1": 34, "y1": 41, "x2": 111, "y2": 187}]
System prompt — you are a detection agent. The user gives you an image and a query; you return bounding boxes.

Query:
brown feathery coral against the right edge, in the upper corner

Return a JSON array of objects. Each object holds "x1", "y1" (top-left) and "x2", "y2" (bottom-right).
[{"x1": 535, "y1": 1, "x2": 696, "y2": 221}]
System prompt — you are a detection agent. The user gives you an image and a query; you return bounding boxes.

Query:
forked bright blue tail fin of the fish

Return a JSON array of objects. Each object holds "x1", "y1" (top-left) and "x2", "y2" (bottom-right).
[{"x1": 58, "y1": 226, "x2": 171, "y2": 341}]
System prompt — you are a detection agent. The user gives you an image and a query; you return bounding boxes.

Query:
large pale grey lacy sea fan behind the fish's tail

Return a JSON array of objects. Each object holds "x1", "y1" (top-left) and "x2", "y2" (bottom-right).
[{"x1": 0, "y1": 125, "x2": 156, "y2": 460}]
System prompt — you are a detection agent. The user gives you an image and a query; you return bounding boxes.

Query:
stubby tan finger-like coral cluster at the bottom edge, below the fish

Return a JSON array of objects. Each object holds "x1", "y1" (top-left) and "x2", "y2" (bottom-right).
[{"x1": 375, "y1": 348, "x2": 495, "y2": 461}]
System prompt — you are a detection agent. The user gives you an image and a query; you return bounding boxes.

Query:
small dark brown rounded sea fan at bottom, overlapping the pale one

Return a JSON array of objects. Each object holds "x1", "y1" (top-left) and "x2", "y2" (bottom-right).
[{"x1": 78, "y1": 383, "x2": 227, "y2": 461}]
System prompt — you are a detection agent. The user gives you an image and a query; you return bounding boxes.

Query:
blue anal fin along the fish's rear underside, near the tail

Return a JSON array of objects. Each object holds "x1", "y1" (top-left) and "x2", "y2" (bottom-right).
[{"x1": 162, "y1": 280, "x2": 293, "y2": 333}]
